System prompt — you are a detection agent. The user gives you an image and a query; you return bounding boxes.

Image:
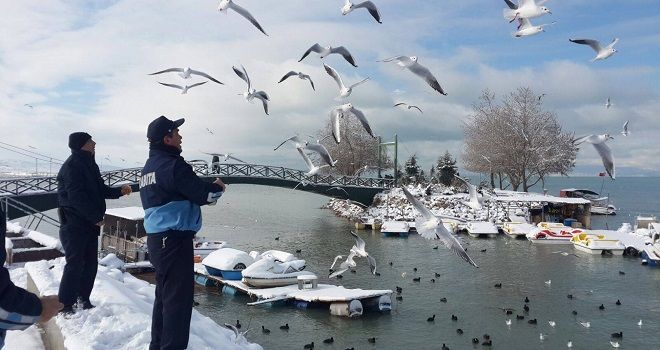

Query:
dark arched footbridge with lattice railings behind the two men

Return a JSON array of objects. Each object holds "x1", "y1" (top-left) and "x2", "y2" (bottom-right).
[{"x1": 0, "y1": 161, "x2": 394, "y2": 220}]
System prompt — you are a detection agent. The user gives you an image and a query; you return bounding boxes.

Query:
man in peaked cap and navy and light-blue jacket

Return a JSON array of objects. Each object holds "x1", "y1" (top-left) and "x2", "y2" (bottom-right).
[{"x1": 140, "y1": 116, "x2": 225, "y2": 350}]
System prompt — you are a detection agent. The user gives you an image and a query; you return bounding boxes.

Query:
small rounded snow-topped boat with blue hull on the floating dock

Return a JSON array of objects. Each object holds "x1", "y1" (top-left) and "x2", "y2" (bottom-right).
[{"x1": 202, "y1": 248, "x2": 254, "y2": 281}]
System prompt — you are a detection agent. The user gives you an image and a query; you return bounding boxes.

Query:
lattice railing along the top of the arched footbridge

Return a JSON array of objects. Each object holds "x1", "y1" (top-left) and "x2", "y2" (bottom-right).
[{"x1": 0, "y1": 161, "x2": 394, "y2": 196}]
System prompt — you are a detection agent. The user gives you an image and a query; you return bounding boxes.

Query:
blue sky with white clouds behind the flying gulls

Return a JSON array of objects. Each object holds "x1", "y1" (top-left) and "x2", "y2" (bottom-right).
[{"x1": 0, "y1": 0, "x2": 660, "y2": 176}]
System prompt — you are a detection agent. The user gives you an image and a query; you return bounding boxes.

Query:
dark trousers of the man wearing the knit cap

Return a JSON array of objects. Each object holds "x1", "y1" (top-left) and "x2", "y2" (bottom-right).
[{"x1": 57, "y1": 223, "x2": 100, "y2": 306}]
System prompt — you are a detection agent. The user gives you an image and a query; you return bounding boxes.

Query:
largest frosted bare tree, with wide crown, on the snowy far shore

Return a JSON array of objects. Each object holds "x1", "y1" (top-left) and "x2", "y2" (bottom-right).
[{"x1": 463, "y1": 88, "x2": 576, "y2": 191}]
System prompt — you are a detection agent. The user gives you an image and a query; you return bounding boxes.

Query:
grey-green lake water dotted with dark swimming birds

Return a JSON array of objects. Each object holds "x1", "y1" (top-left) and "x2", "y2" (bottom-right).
[{"x1": 31, "y1": 178, "x2": 660, "y2": 349}]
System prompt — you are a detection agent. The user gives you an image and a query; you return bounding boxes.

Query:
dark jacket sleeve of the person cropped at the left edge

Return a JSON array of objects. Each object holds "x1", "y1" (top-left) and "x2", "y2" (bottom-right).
[{"x1": 0, "y1": 210, "x2": 41, "y2": 330}]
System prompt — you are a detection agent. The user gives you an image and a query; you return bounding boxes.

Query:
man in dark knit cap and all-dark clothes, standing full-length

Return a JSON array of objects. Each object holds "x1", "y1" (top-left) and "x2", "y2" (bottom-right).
[{"x1": 57, "y1": 132, "x2": 131, "y2": 314}]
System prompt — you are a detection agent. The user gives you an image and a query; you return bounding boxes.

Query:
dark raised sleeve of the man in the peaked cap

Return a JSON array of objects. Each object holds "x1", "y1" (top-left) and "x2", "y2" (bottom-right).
[{"x1": 173, "y1": 159, "x2": 222, "y2": 205}]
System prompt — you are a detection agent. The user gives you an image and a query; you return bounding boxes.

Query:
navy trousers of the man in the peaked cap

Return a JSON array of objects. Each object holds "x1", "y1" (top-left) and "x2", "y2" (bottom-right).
[{"x1": 147, "y1": 232, "x2": 195, "y2": 350}]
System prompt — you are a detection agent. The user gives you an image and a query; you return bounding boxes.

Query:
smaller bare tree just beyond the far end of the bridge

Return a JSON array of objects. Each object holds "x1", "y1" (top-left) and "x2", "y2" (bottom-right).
[{"x1": 318, "y1": 116, "x2": 392, "y2": 175}]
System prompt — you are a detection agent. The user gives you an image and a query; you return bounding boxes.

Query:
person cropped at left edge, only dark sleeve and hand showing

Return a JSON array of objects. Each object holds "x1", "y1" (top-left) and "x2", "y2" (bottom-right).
[{"x1": 0, "y1": 206, "x2": 62, "y2": 349}]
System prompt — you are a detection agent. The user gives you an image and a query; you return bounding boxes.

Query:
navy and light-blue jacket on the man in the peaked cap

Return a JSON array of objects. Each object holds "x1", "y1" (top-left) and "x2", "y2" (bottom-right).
[{"x1": 140, "y1": 144, "x2": 222, "y2": 235}]
